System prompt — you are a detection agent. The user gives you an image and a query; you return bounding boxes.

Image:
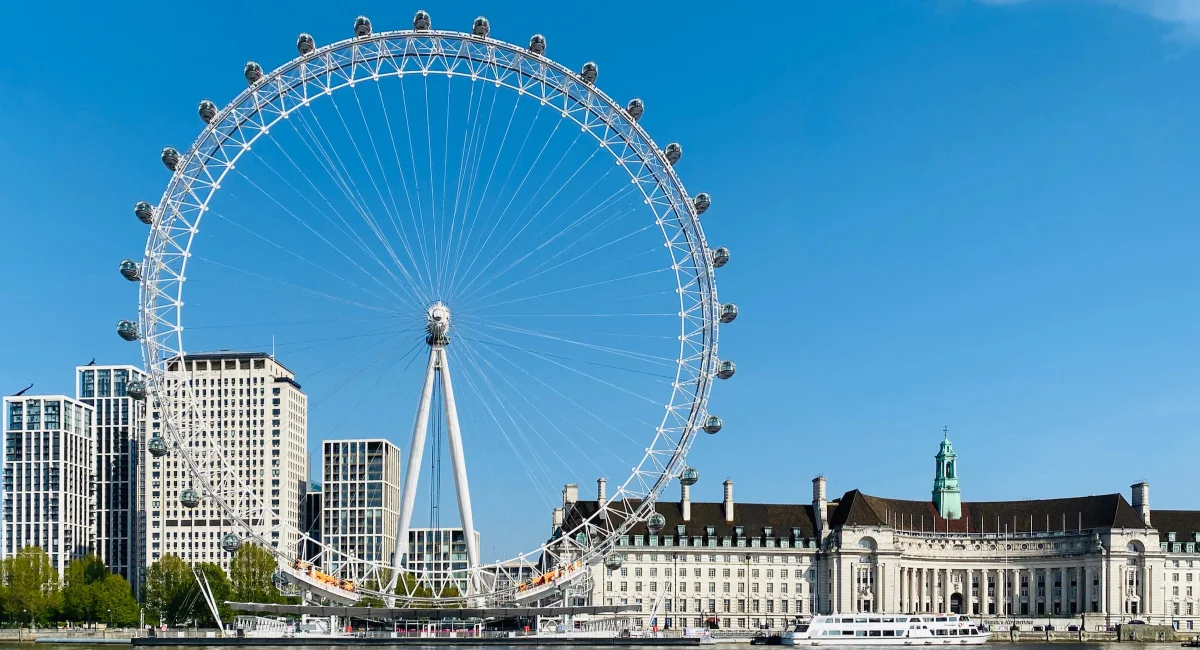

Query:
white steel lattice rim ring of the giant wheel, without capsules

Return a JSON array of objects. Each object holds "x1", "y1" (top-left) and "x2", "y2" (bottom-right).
[{"x1": 138, "y1": 21, "x2": 721, "y2": 611}]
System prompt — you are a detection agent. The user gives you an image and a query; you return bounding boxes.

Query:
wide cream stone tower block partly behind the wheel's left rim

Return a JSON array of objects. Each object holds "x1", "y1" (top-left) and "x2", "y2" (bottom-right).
[{"x1": 143, "y1": 351, "x2": 308, "y2": 570}]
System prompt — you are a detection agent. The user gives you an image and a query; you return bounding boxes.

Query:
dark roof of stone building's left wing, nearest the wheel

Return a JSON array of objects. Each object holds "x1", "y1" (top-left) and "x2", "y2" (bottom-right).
[{"x1": 564, "y1": 501, "x2": 816, "y2": 538}]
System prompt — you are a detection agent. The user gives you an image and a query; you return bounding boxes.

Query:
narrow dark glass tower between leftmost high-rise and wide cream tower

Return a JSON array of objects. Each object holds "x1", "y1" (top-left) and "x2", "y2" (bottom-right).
[{"x1": 76, "y1": 366, "x2": 146, "y2": 594}]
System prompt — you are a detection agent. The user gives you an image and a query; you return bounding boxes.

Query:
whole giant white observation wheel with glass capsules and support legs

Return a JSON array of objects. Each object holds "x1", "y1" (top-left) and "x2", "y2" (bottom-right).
[{"x1": 118, "y1": 11, "x2": 737, "y2": 604}]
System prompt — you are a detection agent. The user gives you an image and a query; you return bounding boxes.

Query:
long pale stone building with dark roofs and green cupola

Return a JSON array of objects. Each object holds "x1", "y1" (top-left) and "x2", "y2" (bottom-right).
[{"x1": 553, "y1": 438, "x2": 1200, "y2": 630}]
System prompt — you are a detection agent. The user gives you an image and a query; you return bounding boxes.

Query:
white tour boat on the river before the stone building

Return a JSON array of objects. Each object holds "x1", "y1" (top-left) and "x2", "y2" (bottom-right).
[{"x1": 782, "y1": 614, "x2": 988, "y2": 645}]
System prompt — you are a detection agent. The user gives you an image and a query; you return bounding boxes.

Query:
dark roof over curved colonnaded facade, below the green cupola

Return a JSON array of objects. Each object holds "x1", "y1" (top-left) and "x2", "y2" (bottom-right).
[{"x1": 832, "y1": 489, "x2": 1153, "y2": 534}]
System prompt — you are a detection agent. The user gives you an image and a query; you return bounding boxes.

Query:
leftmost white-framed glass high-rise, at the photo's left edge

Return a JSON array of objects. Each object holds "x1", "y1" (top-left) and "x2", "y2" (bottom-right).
[{"x1": 4, "y1": 395, "x2": 96, "y2": 576}]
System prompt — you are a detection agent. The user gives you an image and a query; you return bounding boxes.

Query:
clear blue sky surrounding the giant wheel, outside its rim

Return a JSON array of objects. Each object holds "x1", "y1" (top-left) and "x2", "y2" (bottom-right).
[{"x1": 0, "y1": 0, "x2": 1200, "y2": 555}]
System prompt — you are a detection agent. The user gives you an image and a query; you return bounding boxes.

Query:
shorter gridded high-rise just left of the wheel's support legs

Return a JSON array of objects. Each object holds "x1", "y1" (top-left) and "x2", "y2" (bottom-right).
[{"x1": 320, "y1": 439, "x2": 400, "y2": 578}]
